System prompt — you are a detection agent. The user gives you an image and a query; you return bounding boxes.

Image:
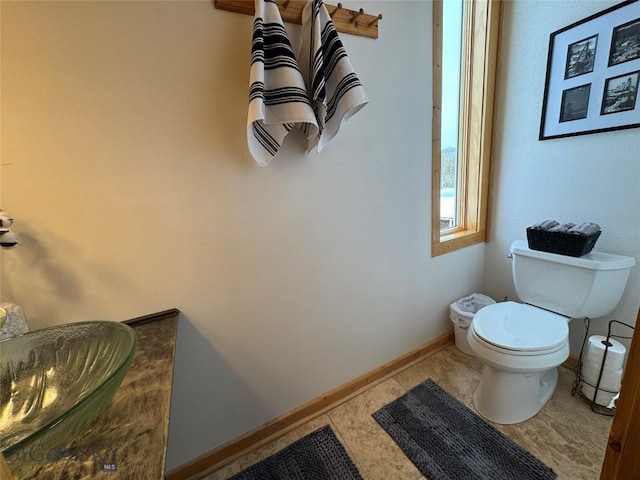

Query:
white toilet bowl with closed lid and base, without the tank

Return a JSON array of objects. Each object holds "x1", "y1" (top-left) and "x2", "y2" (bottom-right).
[{"x1": 467, "y1": 302, "x2": 569, "y2": 424}]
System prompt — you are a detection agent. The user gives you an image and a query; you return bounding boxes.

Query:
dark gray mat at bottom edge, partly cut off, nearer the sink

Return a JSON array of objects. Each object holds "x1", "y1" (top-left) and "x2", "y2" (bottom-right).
[{"x1": 230, "y1": 425, "x2": 362, "y2": 480}]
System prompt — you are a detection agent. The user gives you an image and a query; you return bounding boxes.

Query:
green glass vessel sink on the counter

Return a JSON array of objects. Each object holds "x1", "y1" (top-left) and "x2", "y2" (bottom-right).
[{"x1": 0, "y1": 322, "x2": 136, "y2": 478}]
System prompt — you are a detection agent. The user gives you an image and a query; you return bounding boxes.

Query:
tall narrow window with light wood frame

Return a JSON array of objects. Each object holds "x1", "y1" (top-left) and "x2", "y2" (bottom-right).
[{"x1": 431, "y1": 0, "x2": 501, "y2": 256}]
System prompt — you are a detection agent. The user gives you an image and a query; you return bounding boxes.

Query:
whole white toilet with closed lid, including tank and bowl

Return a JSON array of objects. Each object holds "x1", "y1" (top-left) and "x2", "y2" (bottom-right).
[{"x1": 467, "y1": 240, "x2": 635, "y2": 424}]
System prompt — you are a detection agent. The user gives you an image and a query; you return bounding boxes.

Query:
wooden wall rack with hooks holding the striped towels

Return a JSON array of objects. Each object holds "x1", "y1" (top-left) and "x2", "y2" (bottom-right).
[{"x1": 212, "y1": 0, "x2": 382, "y2": 38}]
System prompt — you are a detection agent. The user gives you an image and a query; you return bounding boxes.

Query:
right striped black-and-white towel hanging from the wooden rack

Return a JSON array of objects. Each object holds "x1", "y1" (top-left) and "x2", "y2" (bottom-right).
[{"x1": 299, "y1": 0, "x2": 369, "y2": 152}]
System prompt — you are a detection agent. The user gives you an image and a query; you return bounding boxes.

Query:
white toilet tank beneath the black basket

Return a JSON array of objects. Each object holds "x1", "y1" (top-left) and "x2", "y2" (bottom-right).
[{"x1": 509, "y1": 240, "x2": 636, "y2": 318}]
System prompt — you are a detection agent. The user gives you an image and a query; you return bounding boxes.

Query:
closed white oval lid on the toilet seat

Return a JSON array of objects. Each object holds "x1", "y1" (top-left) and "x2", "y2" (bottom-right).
[{"x1": 472, "y1": 302, "x2": 569, "y2": 352}]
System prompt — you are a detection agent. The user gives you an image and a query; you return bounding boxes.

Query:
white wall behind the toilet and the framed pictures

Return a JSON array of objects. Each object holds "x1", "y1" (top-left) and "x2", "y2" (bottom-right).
[{"x1": 484, "y1": 1, "x2": 640, "y2": 356}]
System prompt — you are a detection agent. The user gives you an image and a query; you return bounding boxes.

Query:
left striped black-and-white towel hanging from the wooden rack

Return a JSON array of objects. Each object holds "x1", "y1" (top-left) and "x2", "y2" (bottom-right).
[{"x1": 247, "y1": 0, "x2": 318, "y2": 167}]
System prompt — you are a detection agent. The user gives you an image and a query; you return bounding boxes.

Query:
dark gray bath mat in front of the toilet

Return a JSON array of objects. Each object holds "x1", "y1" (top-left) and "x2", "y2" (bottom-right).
[{"x1": 373, "y1": 379, "x2": 556, "y2": 480}]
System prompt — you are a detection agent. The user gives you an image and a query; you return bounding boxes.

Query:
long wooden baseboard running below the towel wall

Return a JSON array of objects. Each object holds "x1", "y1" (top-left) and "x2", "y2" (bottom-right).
[{"x1": 165, "y1": 330, "x2": 455, "y2": 480}]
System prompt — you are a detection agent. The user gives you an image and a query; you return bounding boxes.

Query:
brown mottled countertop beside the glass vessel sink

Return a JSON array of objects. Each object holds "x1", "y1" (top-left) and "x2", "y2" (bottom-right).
[{"x1": 23, "y1": 310, "x2": 179, "y2": 480}]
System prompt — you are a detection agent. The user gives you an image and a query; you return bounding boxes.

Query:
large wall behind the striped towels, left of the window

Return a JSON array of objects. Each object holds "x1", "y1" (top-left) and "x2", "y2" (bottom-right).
[{"x1": 1, "y1": 1, "x2": 484, "y2": 468}]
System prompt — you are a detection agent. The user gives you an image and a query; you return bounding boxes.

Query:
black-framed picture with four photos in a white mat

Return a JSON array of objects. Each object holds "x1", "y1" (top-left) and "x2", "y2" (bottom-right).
[{"x1": 538, "y1": 0, "x2": 640, "y2": 140}]
